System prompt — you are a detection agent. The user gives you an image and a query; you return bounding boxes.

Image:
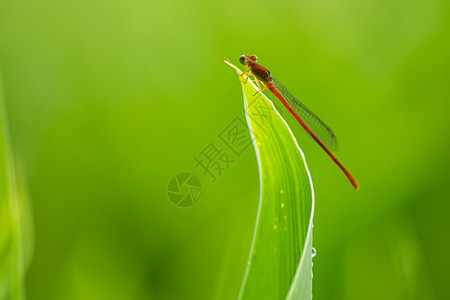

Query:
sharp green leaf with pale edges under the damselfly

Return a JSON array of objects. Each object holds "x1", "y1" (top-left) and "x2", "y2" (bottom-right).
[{"x1": 224, "y1": 60, "x2": 314, "y2": 300}]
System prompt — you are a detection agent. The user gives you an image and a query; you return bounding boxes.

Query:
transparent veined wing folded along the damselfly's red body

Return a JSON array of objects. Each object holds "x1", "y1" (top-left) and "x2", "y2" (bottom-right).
[{"x1": 273, "y1": 78, "x2": 339, "y2": 151}]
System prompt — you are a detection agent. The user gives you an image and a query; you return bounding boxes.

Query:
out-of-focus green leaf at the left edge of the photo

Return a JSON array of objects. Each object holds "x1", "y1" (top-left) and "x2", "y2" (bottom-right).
[{"x1": 0, "y1": 71, "x2": 33, "y2": 300}]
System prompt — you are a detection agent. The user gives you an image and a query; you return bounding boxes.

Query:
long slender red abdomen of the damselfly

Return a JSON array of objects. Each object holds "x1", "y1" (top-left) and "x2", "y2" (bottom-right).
[{"x1": 266, "y1": 82, "x2": 359, "y2": 190}]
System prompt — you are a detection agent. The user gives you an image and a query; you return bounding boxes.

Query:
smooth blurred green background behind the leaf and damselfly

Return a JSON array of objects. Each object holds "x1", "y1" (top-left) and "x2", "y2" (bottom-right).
[{"x1": 0, "y1": 0, "x2": 450, "y2": 300}]
